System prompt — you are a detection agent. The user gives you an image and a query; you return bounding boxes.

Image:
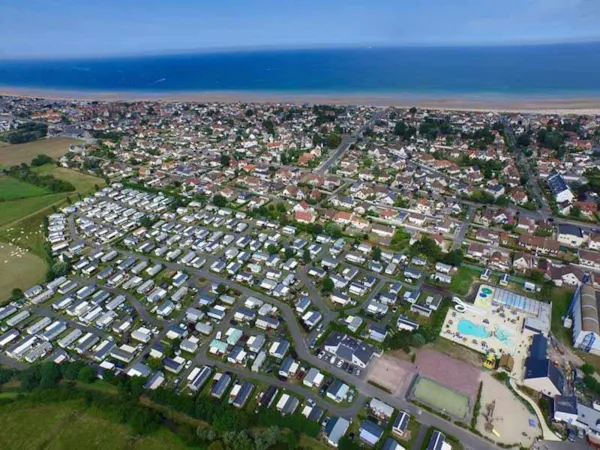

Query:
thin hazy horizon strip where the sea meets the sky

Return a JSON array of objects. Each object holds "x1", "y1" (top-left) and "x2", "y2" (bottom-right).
[{"x1": 0, "y1": 37, "x2": 600, "y2": 62}]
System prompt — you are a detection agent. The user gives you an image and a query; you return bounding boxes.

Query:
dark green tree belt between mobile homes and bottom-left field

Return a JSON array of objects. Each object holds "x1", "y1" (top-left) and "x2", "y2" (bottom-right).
[{"x1": 0, "y1": 361, "x2": 320, "y2": 450}]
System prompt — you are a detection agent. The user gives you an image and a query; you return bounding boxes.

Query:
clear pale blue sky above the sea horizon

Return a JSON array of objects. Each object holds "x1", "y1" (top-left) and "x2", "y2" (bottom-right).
[{"x1": 0, "y1": 0, "x2": 600, "y2": 58}]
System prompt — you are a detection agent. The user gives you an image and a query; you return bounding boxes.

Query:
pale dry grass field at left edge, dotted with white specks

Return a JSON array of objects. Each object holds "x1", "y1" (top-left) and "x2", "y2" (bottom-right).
[{"x1": 0, "y1": 242, "x2": 46, "y2": 306}]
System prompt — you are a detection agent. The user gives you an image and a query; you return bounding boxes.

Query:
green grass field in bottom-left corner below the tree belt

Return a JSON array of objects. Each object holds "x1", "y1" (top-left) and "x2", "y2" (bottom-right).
[{"x1": 0, "y1": 402, "x2": 186, "y2": 450}]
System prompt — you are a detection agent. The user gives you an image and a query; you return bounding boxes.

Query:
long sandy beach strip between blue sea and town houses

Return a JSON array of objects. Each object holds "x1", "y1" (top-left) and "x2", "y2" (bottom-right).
[{"x1": 0, "y1": 87, "x2": 600, "y2": 115}]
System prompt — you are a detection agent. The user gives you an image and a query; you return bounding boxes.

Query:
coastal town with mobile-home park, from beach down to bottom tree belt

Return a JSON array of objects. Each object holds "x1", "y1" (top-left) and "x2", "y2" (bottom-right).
[{"x1": 0, "y1": 92, "x2": 600, "y2": 450}]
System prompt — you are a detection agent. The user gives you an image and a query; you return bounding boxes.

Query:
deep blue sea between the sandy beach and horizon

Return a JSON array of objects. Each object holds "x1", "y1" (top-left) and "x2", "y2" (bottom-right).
[{"x1": 0, "y1": 43, "x2": 600, "y2": 97}]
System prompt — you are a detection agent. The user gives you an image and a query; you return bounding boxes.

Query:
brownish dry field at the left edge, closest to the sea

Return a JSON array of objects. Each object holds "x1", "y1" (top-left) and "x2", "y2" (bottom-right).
[{"x1": 0, "y1": 138, "x2": 83, "y2": 167}]
